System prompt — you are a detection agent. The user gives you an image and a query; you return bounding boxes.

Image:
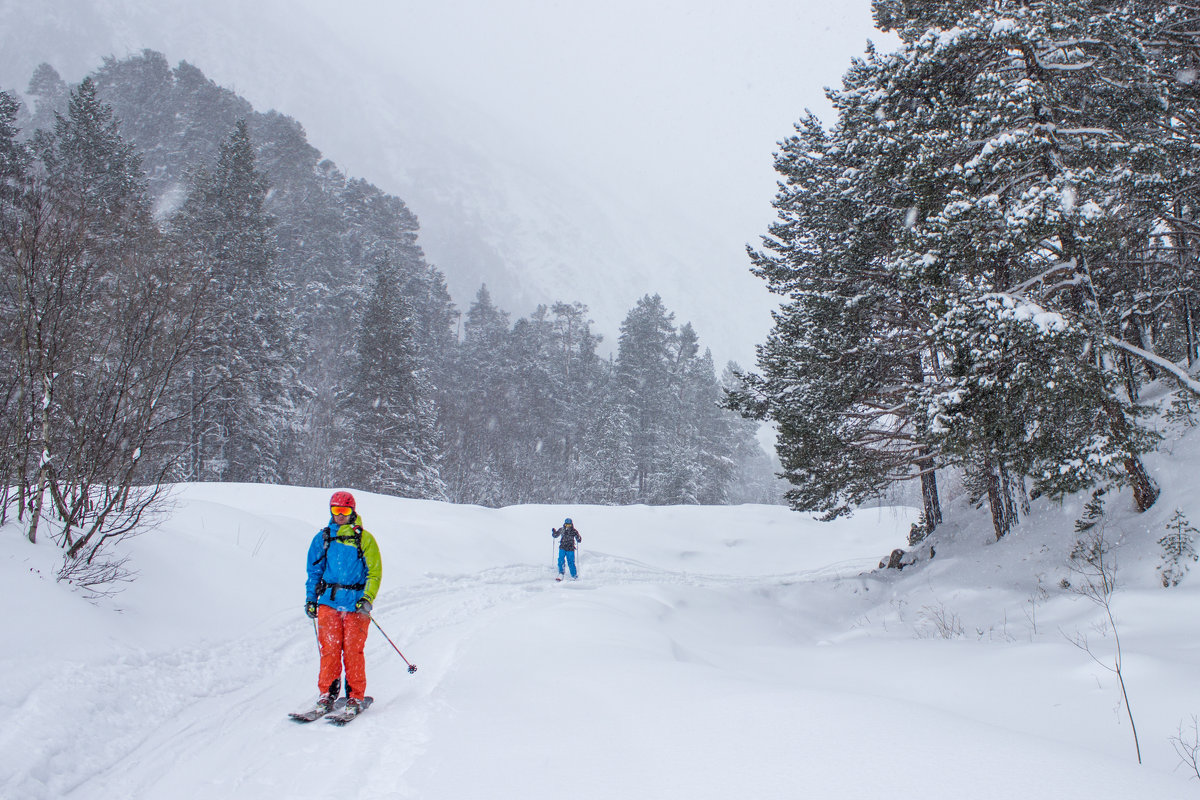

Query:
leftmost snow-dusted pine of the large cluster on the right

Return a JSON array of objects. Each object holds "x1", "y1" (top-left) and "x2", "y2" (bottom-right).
[{"x1": 727, "y1": 100, "x2": 941, "y2": 533}]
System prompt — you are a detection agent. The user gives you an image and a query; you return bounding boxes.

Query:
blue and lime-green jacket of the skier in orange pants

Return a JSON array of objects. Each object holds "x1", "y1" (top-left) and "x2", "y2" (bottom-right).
[{"x1": 305, "y1": 513, "x2": 383, "y2": 612}]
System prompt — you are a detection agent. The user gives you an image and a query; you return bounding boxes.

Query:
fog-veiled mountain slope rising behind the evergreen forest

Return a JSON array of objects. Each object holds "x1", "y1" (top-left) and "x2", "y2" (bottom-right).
[{"x1": 0, "y1": 0, "x2": 769, "y2": 365}]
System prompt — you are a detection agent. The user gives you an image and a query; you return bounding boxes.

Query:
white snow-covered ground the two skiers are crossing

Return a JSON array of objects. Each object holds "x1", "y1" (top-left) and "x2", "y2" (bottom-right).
[{"x1": 0, "y1": 435, "x2": 1200, "y2": 800}]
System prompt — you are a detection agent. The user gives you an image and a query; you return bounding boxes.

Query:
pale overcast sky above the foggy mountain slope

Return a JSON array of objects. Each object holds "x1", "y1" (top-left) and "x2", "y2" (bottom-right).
[{"x1": 307, "y1": 0, "x2": 892, "y2": 242}]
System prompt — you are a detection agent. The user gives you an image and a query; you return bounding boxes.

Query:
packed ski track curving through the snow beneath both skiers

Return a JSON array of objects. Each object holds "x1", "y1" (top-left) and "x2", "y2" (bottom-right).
[{"x1": 9, "y1": 551, "x2": 871, "y2": 800}]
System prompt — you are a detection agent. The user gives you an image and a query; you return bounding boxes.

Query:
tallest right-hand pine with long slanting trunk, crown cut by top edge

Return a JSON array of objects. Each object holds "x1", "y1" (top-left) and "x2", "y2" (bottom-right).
[{"x1": 862, "y1": 1, "x2": 1160, "y2": 532}]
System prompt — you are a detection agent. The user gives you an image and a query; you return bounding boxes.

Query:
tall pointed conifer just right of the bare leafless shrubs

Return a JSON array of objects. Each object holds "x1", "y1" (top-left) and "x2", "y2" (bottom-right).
[{"x1": 172, "y1": 121, "x2": 300, "y2": 481}]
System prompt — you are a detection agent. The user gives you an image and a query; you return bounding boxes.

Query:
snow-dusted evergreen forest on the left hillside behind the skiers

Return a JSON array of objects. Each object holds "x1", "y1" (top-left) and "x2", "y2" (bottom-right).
[{"x1": 0, "y1": 50, "x2": 778, "y2": 563}]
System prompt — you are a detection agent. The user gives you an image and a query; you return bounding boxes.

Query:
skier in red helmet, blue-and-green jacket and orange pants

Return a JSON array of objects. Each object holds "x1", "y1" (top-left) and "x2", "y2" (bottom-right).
[{"x1": 304, "y1": 492, "x2": 383, "y2": 711}]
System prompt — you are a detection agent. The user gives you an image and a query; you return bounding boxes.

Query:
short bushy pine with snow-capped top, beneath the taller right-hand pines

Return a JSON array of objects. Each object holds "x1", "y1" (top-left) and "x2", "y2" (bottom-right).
[{"x1": 914, "y1": 294, "x2": 1114, "y2": 539}]
